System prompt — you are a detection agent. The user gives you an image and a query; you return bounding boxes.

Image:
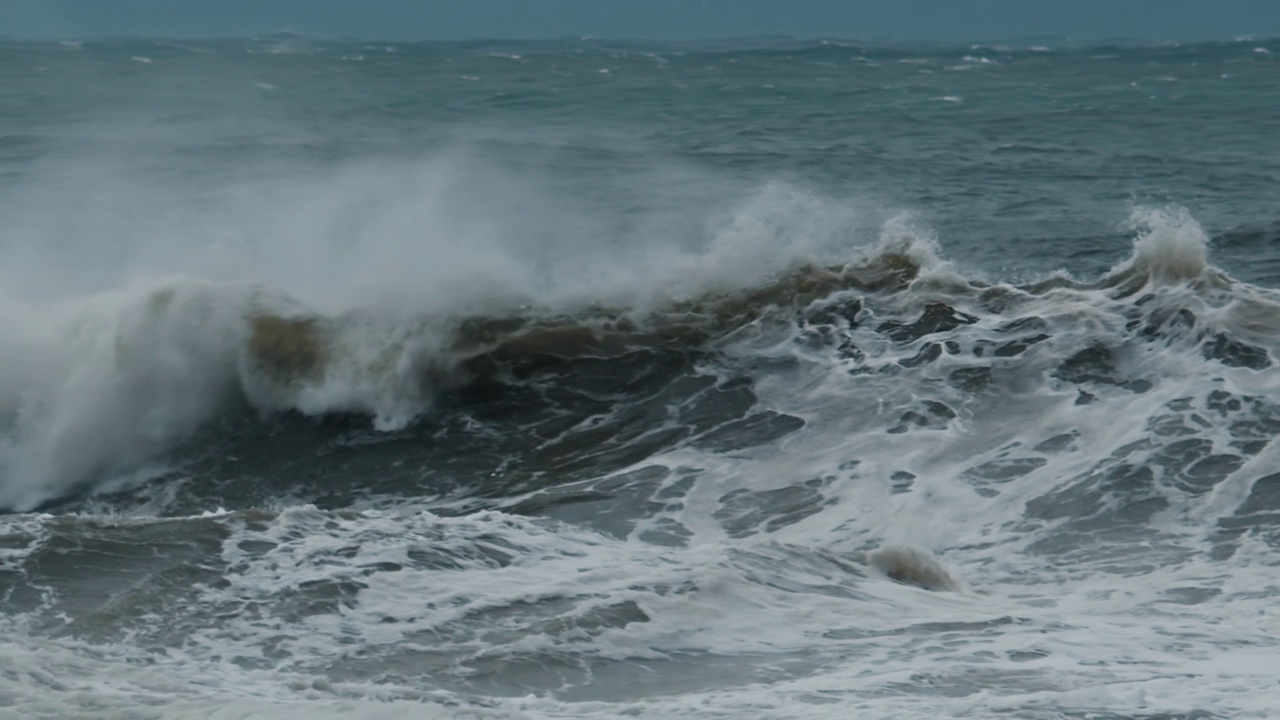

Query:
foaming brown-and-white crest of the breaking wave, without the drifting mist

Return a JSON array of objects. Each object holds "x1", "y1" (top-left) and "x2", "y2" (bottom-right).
[{"x1": 0, "y1": 209, "x2": 1271, "y2": 510}]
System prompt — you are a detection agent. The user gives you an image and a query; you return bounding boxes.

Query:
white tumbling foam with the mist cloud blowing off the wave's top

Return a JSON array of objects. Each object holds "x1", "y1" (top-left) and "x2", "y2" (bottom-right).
[{"x1": 0, "y1": 140, "x2": 876, "y2": 509}]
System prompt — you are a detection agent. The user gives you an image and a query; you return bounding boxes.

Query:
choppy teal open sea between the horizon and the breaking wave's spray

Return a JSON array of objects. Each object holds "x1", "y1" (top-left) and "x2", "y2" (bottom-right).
[{"x1": 0, "y1": 36, "x2": 1280, "y2": 282}]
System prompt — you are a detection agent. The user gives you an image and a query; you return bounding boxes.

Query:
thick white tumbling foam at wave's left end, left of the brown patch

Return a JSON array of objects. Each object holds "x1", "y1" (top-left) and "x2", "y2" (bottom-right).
[{"x1": 0, "y1": 281, "x2": 257, "y2": 510}]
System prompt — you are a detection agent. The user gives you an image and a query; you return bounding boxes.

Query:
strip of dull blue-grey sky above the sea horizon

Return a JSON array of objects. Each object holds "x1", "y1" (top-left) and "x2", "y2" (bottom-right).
[{"x1": 0, "y1": 0, "x2": 1280, "y2": 40}]
